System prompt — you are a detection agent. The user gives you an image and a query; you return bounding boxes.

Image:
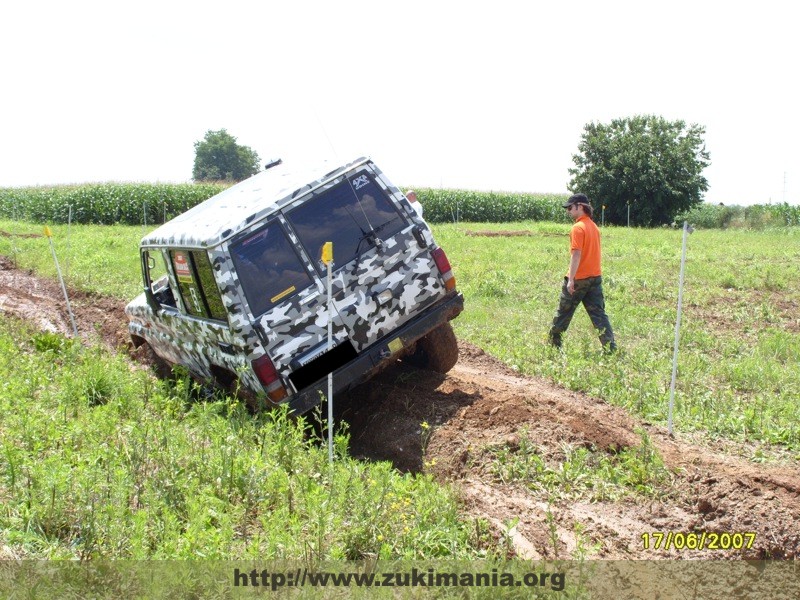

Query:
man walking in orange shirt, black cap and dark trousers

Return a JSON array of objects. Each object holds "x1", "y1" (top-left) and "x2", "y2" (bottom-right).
[{"x1": 550, "y1": 194, "x2": 617, "y2": 352}]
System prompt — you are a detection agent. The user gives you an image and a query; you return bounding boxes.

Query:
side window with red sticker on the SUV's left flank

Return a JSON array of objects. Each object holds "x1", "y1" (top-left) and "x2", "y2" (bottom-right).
[{"x1": 169, "y1": 250, "x2": 226, "y2": 321}]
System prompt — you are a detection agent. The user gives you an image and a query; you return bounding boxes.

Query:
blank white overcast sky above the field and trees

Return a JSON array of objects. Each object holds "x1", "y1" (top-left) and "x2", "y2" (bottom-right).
[{"x1": 0, "y1": 0, "x2": 800, "y2": 204}]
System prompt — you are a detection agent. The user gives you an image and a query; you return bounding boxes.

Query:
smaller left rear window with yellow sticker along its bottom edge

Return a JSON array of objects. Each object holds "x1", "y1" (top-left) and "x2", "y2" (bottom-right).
[{"x1": 231, "y1": 221, "x2": 312, "y2": 316}]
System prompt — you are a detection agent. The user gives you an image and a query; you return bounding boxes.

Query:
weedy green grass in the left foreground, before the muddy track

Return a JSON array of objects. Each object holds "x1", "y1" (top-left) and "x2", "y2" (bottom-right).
[{"x1": 0, "y1": 319, "x2": 486, "y2": 561}]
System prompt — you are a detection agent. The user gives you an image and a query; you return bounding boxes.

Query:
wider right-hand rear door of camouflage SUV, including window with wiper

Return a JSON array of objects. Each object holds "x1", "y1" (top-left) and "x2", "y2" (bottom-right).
[{"x1": 286, "y1": 168, "x2": 445, "y2": 353}]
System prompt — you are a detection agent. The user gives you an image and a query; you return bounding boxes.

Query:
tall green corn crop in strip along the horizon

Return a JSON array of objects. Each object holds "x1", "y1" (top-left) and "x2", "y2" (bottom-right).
[{"x1": 0, "y1": 183, "x2": 800, "y2": 229}]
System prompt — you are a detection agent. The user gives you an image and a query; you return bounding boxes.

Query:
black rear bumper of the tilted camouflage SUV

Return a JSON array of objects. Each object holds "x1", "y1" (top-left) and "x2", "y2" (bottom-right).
[{"x1": 288, "y1": 290, "x2": 464, "y2": 415}]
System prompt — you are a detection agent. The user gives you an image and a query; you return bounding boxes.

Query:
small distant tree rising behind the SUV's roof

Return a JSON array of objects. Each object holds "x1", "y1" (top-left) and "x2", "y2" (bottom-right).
[{"x1": 192, "y1": 129, "x2": 261, "y2": 181}]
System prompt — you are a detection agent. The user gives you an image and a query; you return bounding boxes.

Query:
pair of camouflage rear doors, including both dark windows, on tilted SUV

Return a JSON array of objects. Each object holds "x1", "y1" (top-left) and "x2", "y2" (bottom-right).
[{"x1": 229, "y1": 168, "x2": 445, "y2": 396}]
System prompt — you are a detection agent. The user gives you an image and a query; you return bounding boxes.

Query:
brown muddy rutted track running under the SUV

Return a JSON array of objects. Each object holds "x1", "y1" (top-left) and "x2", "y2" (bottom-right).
[{"x1": 0, "y1": 257, "x2": 800, "y2": 559}]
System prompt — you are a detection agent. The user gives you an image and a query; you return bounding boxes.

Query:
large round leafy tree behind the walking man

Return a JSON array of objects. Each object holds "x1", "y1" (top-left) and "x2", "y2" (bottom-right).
[{"x1": 569, "y1": 115, "x2": 711, "y2": 226}]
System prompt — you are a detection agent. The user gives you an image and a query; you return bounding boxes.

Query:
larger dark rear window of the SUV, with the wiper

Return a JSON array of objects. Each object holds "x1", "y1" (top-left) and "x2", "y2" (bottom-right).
[{"x1": 286, "y1": 173, "x2": 406, "y2": 274}]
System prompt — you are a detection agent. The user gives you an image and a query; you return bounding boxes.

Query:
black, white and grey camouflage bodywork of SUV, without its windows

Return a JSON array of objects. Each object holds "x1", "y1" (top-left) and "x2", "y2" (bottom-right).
[{"x1": 126, "y1": 158, "x2": 454, "y2": 406}]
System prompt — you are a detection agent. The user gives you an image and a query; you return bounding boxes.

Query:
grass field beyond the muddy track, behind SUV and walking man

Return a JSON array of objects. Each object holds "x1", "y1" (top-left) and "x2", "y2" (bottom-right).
[{"x1": 0, "y1": 221, "x2": 800, "y2": 451}]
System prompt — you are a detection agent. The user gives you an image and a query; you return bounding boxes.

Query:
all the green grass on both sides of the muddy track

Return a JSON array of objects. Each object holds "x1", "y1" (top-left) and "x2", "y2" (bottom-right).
[{"x1": 0, "y1": 221, "x2": 800, "y2": 559}]
